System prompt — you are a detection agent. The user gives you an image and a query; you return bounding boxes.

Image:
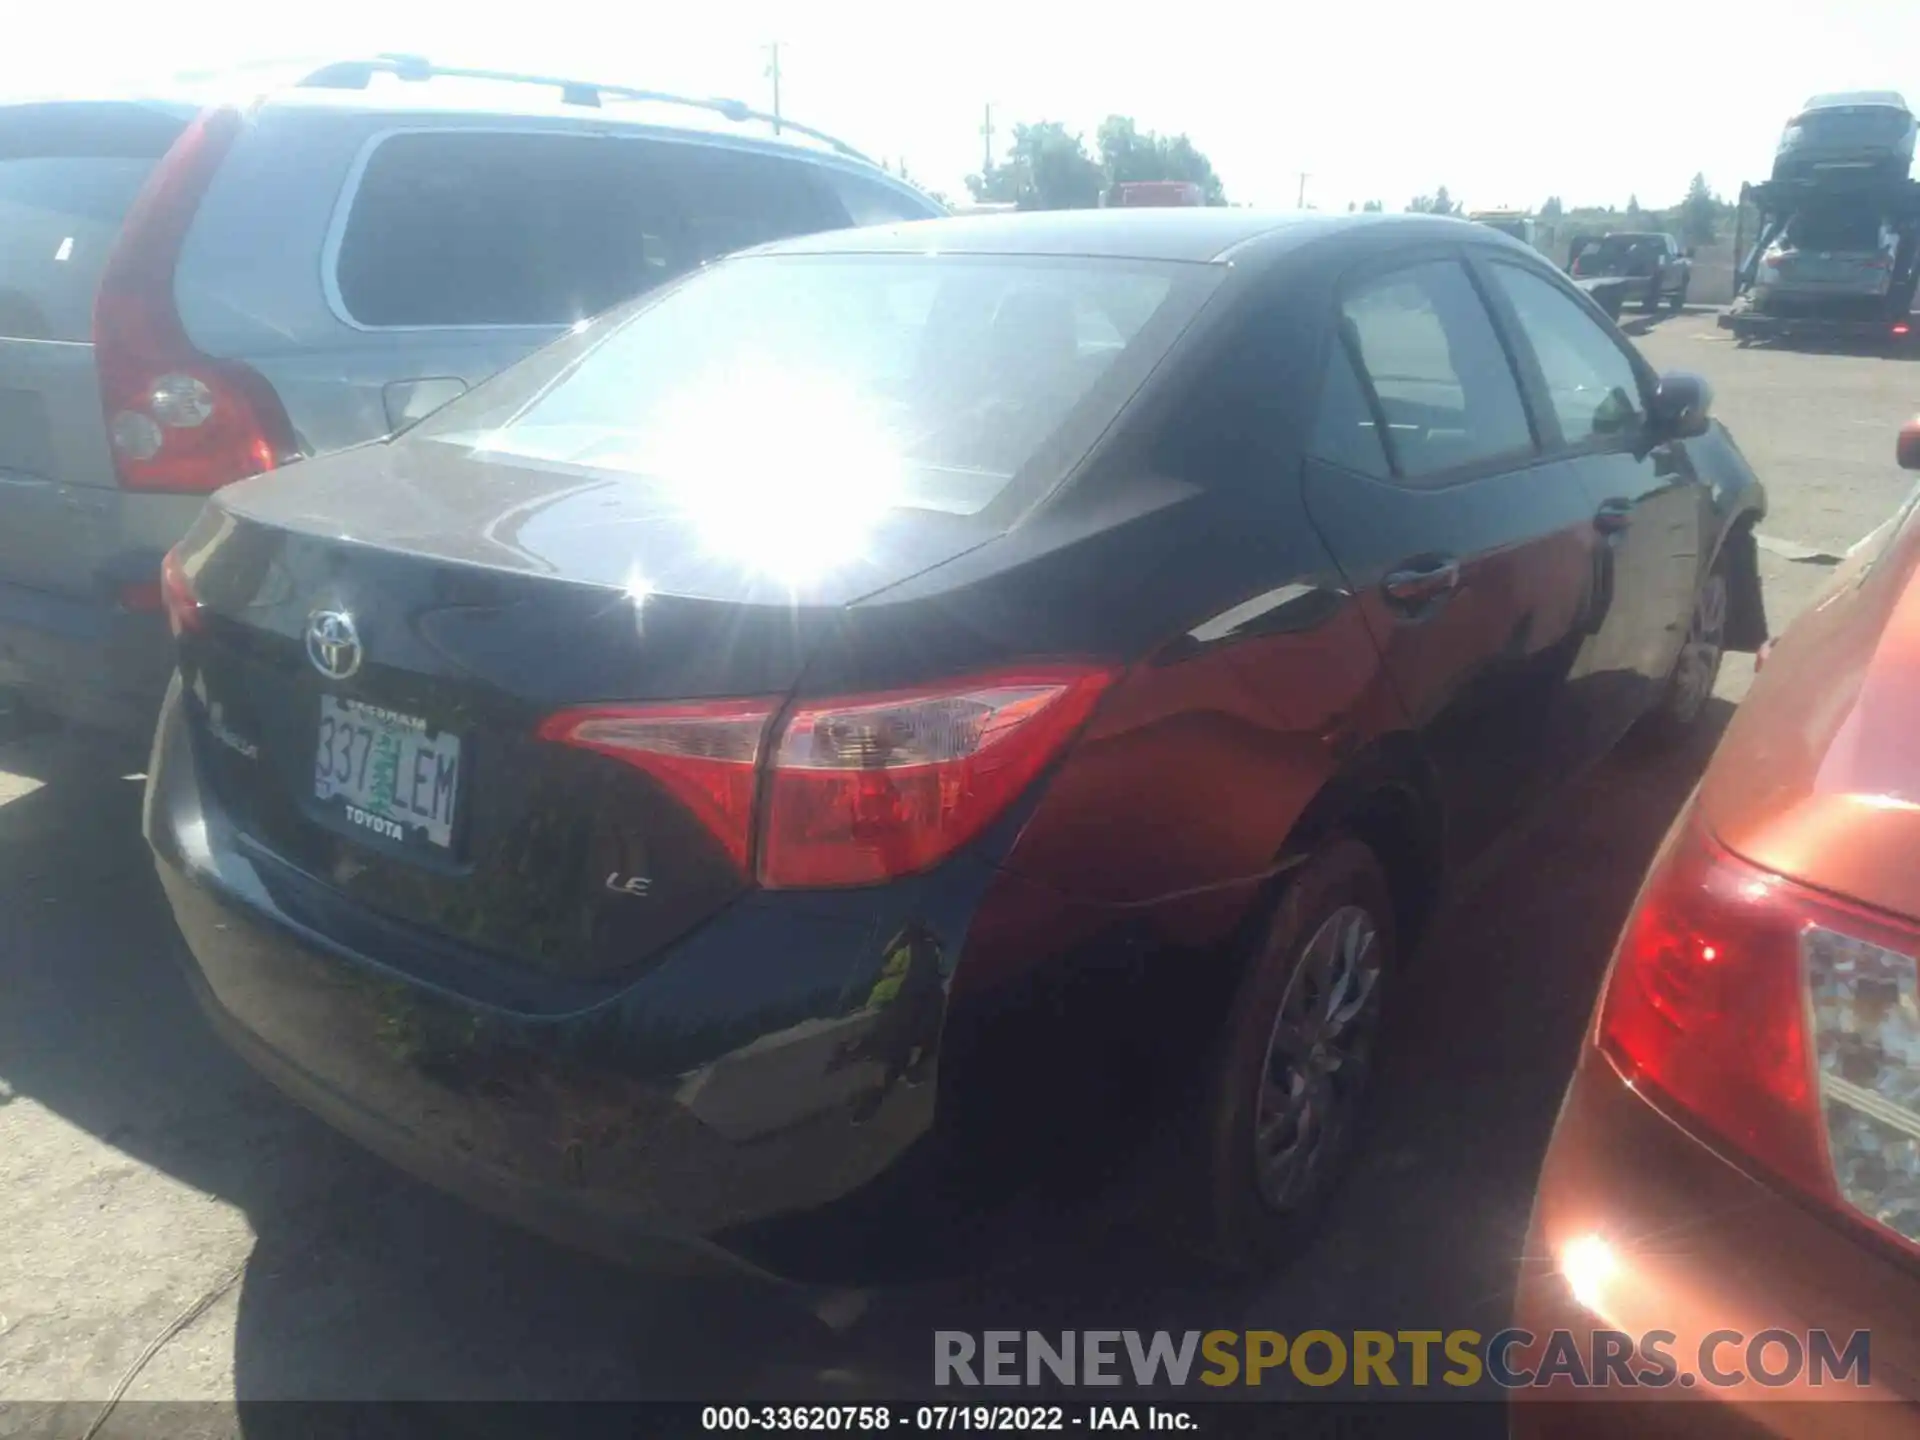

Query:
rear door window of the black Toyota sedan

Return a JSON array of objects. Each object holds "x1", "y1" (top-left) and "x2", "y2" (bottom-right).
[{"x1": 1340, "y1": 259, "x2": 1534, "y2": 480}]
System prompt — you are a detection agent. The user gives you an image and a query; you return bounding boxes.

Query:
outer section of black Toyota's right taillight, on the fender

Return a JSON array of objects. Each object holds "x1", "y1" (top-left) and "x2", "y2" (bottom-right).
[{"x1": 760, "y1": 668, "x2": 1114, "y2": 887}]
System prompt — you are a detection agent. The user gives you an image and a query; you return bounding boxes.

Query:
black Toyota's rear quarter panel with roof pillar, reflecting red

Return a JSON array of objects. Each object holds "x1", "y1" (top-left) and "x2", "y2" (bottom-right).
[{"x1": 840, "y1": 253, "x2": 1407, "y2": 987}]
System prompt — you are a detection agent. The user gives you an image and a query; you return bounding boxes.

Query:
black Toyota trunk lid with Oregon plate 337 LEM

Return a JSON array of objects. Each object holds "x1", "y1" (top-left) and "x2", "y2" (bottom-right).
[{"x1": 177, "y1": 442, "x2": 979, "y2": 979}]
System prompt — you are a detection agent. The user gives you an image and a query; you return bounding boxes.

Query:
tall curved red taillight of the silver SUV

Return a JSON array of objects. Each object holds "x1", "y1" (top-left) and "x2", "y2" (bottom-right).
[{"x1": 94, "y1": 108, "x2": 296, "y2": 493}]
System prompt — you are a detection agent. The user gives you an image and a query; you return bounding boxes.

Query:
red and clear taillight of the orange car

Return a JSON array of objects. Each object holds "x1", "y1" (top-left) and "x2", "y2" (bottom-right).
[{"x1": 1597, "y1": 818, "x2": 1920, "y2": 1248}]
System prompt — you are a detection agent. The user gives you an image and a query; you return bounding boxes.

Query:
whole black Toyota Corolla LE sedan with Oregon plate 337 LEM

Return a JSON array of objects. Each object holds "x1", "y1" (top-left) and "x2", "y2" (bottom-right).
[{"x1": 146, "y1": 209, "x2": 1766, "y2": 1267}]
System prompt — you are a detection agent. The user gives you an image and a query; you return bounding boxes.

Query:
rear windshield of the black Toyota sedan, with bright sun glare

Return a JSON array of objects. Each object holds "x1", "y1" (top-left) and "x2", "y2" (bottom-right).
[{"x1": 413, "y1": 255, "x2": 1217, "y2": 515}]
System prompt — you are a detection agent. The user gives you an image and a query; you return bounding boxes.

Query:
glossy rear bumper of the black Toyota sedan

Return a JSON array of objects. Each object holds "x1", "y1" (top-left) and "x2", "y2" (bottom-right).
[{"x1": 146, "y1": 682, "x2": 1098, "y2": 1275}]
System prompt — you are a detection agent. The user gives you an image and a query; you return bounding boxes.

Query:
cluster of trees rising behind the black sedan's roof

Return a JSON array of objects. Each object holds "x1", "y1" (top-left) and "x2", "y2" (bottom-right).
[{"x1": 966, "y1": 115, "x2": 1227, "y2": 209}]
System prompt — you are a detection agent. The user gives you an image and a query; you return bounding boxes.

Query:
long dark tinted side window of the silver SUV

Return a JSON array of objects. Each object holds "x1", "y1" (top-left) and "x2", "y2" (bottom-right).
[{"x1": 334, "y1": 131, "x2": 847, "y2": 326}]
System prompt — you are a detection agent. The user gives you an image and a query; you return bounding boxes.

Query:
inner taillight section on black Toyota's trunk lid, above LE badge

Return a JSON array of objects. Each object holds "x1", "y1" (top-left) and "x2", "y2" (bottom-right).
[{"x1": 540, "y1": 701, "x2": 780, "y2": 872}]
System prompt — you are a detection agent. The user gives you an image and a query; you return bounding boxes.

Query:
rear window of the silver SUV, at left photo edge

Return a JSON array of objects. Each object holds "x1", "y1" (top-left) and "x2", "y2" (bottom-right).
[{"x1": 0, "y1": 156, "x2": 157, "y2": 340}]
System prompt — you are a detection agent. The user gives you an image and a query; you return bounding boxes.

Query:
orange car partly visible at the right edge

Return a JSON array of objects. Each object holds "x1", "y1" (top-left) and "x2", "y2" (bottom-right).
[{"x1": 1488, "y1": 420, "x2": 1920, "y2": 1438}]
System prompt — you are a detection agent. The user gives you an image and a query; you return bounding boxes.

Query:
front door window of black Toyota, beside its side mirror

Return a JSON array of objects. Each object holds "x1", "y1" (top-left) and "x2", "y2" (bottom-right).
[{"x1": 1488, "y1": 263, "x2": 1645, "y2": 445}]
